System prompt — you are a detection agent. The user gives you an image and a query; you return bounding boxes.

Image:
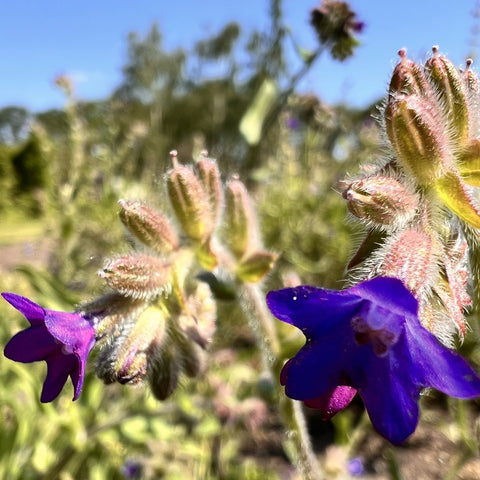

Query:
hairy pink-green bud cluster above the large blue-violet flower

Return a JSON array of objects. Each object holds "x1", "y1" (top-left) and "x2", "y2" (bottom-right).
[{"x1": 341, "y1": 47, "x2": 480, "y2": 342}]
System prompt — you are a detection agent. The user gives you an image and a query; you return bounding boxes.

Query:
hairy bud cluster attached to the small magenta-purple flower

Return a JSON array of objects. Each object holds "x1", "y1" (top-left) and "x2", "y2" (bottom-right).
[{"x1": 82, "y1": 152, "x2": 276, "y2": 400}]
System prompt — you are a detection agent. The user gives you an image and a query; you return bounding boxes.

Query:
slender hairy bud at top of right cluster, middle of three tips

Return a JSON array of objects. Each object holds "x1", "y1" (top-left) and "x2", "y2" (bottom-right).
[{"x1": 425, "y1": 47, "x2": 469, "y2": 142}]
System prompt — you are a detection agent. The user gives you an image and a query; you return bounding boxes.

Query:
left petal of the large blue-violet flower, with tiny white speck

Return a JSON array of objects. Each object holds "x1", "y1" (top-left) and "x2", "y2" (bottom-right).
[{"x1": 267, "y1": 286, "x2": 362, "y2": 337}]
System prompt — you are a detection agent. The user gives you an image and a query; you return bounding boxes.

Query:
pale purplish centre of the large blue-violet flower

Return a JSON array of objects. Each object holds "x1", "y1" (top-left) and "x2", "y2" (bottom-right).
[{"x1": 351, "y1": 308, "x2": 398, "y2": 357}]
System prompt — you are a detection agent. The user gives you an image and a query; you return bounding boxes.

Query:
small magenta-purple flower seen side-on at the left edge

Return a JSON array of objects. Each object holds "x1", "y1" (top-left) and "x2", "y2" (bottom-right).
[{"x1": 2, "y1": 293, "x2": 95, "y2": 403}]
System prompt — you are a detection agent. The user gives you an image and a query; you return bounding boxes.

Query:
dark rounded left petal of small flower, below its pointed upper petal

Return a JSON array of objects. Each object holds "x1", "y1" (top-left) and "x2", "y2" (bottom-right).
[{"x1": 3, "y1": 326, "x2": 60, "y2": 363}]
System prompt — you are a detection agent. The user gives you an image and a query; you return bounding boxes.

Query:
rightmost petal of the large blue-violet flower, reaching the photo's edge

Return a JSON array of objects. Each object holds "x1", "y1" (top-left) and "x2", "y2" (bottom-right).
[{"x1": 406, "y1": 322, "x2": 480, "y2": 398}]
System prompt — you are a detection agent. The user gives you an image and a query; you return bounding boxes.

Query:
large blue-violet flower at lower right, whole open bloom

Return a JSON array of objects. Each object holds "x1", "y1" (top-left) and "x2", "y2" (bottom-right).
[{"x1": 267, "y1": 277, "x2": 480, "y2": 444}]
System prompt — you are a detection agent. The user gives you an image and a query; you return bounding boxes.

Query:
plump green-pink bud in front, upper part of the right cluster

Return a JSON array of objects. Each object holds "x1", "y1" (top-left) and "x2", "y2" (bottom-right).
[{"x1": 385, "y1": 95, "x2": 451, "y2": 186}]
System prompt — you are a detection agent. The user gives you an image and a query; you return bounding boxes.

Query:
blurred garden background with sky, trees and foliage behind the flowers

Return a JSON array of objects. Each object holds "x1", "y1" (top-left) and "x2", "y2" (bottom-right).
[{"x1": 0, "y1": 0, "x2": 480, "y2": 480}]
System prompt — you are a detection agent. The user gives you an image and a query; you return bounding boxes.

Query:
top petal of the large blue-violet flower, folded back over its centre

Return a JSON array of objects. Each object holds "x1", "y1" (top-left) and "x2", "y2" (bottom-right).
[{"x1": 348, "y1": 277, "x2": 418, "y2": 318}]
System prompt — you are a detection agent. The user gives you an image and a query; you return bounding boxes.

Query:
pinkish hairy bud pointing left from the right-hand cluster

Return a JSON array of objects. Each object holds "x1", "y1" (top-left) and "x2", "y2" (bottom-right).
[{"x1": 343, "y1": 176, "x2": 419, "y2": 225}]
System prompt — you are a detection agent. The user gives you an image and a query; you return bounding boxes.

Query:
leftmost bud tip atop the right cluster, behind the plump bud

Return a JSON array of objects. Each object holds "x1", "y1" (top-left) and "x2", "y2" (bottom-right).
[{"x1": 388, "y1": 48, "x2": 433, "y2": 97}]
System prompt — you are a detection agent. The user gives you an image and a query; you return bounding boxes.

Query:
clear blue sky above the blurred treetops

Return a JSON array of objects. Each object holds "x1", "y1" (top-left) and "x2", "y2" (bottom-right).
[{"x1": 0, "y1": 0, "x2": 480, "y2": 111}]
